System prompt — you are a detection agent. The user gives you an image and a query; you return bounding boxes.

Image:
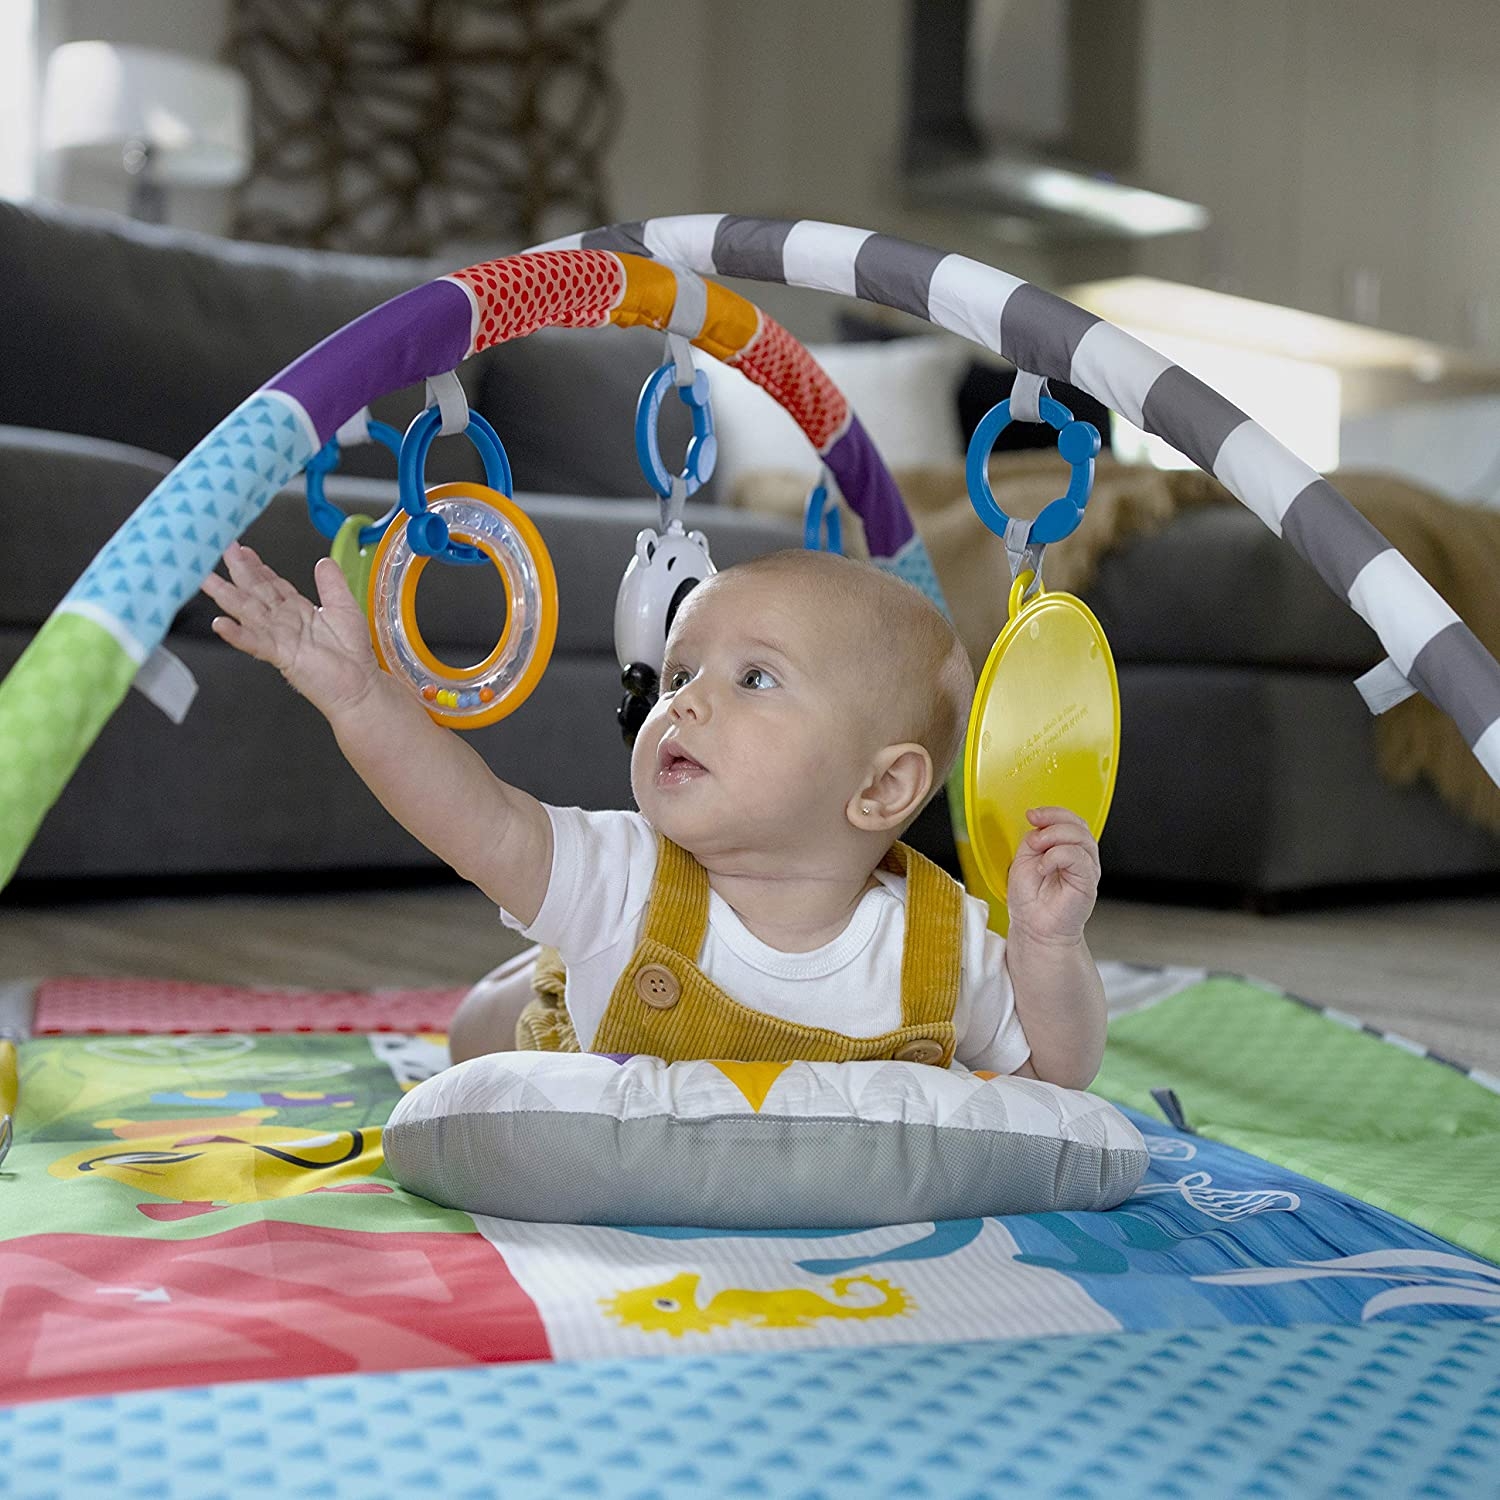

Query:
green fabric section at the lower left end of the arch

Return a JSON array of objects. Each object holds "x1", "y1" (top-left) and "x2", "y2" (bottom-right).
[{"x1": 0, "y1": 615, "x2": 137, "y2": 888}]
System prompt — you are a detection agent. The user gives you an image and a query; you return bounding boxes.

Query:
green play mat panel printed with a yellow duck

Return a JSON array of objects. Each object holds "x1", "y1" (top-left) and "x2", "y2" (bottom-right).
[{"x1": 0, "y1": 1034, "x2": 474, "y2": 1241}]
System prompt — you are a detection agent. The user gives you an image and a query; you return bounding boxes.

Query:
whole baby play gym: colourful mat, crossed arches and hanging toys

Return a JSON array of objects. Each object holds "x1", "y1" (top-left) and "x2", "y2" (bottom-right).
[{"x1": 0, "y1": 215, "x2": 1500, "y2": 1500}]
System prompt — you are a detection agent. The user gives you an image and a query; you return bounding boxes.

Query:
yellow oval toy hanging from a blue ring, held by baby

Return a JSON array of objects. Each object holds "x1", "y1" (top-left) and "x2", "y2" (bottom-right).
[{"x1": 959, "y1": 377, "x2": 1121, "y2": 933}]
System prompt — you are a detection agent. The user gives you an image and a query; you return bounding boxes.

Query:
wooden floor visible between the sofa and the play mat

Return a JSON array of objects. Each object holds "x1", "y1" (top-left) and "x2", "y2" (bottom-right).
[{"x1": 0, "y1": 885, "x2": 1500, "y2": 1074}]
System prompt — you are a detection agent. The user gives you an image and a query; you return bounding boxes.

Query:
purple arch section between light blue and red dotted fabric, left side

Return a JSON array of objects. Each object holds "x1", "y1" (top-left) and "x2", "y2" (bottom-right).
[{"x1": 266, "y1": 281, "x2": 473, "y2": 443}]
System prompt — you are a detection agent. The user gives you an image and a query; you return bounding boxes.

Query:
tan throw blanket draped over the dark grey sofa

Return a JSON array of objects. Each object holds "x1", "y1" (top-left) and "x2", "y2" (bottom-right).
[{"x1": 734, "y1": 452, "x2": 1500, "y2": 833}]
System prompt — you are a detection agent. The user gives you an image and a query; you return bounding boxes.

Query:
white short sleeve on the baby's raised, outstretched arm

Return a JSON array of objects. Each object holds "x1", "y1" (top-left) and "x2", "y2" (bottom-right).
[{"x1": 500, "y1": 803, "x2": 657, "y2": 963}]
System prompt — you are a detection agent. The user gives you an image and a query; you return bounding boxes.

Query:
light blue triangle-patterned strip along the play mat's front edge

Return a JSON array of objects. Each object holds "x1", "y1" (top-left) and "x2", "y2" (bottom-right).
[{"x1": 0, "y1": 1322, "x2": 1500, "y2": 1500}]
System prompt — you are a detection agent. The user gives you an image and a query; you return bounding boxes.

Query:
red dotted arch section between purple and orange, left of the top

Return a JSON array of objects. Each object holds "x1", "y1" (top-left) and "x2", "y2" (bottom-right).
[{"x1": 444, "y1": 251, "x2": 626, "y2": 354}]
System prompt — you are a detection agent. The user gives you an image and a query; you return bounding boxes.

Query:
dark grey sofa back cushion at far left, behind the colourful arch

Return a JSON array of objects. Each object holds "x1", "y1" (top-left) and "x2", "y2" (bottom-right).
[{"x1": 0, "y1": 203, "x2": 483, "y2": 479}]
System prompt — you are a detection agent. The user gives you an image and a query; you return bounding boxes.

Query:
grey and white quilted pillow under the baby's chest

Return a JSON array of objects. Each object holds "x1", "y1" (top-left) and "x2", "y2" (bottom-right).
[{"x1": 386, "y1": 1052, "x2": 1148, "y2": 1229}]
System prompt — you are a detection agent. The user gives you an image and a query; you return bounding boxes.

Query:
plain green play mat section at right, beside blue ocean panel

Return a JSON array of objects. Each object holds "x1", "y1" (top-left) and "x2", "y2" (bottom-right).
[{"x1": 1094, "y1": 975, "x2": 1500, "y2": 1262}]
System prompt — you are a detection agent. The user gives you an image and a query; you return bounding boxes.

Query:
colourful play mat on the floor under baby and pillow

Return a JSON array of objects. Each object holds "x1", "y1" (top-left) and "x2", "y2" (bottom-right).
[{"x1": 0, "y1": 966, "x2": 1500, "y2": 1500}]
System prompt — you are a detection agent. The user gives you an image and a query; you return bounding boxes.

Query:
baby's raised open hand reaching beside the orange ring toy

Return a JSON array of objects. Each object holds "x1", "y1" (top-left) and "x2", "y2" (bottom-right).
[{"x1": 203, "y1": 542, "x2": 380, "y2": 719}]
